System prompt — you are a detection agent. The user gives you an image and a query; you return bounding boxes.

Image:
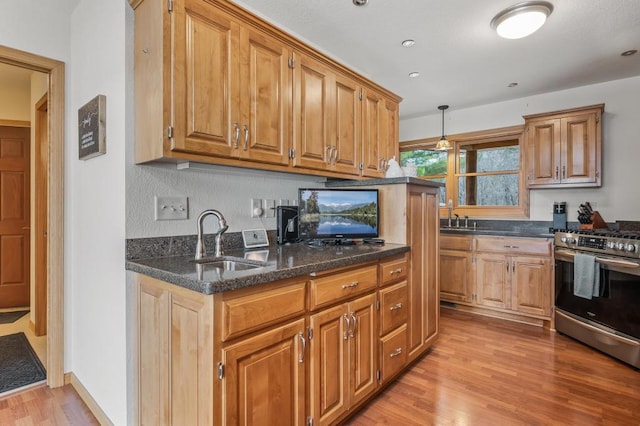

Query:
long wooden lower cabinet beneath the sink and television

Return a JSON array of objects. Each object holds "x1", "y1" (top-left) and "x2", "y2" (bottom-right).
[{"x1": 132, "y1": 248, "x2": 433, "y2": 426}]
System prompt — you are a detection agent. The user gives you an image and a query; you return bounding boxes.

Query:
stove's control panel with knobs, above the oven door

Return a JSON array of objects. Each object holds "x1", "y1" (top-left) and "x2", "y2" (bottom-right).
[{"x1": 554, "y1": 229, "x2": 640, "y2": 259}]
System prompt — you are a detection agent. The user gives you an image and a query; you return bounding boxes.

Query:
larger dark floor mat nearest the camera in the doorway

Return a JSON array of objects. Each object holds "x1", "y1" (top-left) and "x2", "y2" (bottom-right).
[{"x1": 0, "y1": 333, "x2": 47, "y2": 393}]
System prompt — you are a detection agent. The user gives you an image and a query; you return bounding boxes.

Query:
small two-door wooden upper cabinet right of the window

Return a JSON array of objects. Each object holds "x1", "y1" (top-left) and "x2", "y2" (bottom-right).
[{"x1": 524, "y1": 104, "x2": 604, "y2": 188}]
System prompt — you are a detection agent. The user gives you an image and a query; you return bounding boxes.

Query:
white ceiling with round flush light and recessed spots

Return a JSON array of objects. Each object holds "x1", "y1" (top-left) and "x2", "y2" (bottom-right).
[{"x1": 234, "y1": 0, "x2": 640, "y2": 118}]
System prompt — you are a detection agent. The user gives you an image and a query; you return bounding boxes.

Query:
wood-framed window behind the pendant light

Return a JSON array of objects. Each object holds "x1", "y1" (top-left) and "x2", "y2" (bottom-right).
[{"x1": 400, "y1": 126, "x2": 529, "y2": 218}]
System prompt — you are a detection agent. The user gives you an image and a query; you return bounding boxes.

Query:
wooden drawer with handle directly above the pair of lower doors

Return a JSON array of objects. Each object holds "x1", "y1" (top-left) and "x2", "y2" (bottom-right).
[{"x1": 309, "y1": 265, "x2": 378, "y2": 309}]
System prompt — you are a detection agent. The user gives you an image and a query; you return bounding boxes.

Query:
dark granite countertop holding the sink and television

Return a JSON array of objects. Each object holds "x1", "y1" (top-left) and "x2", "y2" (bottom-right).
[{"x1": 126, "y1": 243, "x2": 409, "y2": 294}]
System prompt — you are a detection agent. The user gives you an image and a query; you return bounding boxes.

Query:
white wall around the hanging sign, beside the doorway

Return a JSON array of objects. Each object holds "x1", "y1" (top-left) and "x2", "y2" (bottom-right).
[{"x1": 0, "y1": 0, "x2": 132, "y2": 425}]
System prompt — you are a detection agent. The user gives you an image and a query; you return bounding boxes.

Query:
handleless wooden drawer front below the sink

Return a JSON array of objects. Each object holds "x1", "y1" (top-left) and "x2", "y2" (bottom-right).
[{"x1": 221, "y1": 282, "x2": 305, "y2": 342}]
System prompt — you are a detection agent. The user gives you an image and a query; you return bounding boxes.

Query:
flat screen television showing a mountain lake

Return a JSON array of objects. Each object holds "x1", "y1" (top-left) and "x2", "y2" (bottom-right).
[{"x1": 298, "y1": 188, "x2": 379, "y2": 240}]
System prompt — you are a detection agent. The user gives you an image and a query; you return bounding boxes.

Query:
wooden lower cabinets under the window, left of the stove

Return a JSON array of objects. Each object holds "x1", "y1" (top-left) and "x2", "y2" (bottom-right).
[{"x1": 440, "y1": 235, "x2": 553, "y2": 322}]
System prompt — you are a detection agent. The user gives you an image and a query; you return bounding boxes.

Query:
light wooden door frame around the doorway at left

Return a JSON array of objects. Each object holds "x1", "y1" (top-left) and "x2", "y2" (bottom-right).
[{"x1": 0, "y1": 45, "x2": 65, "y2": 388}]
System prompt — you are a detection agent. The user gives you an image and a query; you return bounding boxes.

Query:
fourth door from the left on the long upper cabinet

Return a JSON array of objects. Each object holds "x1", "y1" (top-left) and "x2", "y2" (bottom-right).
[{"x1": 330, "y1": 74, "x2": 362, "y2": 175}]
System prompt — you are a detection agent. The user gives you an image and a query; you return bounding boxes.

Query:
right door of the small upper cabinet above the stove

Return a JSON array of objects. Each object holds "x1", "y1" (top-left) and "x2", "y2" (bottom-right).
[{"x1": 561, "y1": 113, "x2": 599, "y2": 183}]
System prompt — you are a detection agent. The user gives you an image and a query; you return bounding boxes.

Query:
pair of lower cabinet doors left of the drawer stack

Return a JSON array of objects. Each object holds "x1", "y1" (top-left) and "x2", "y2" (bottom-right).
[{"x1": 309, "y1": 293, "x2": 378, "y2": 425}]
